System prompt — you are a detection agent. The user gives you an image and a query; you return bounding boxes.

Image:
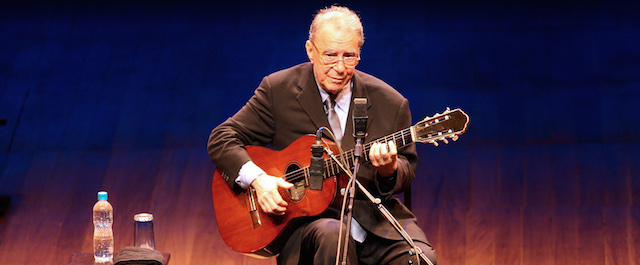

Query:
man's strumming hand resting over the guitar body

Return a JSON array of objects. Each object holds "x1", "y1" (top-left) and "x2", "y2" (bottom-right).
[{"x1": 251, "y1": 174, "x2": 293, "y2": 215}]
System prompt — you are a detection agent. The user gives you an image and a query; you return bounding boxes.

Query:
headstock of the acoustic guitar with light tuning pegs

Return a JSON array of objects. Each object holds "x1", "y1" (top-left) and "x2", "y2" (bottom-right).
[{"x1": 411, "y1": 108, "x2": 469, "y2": 146}]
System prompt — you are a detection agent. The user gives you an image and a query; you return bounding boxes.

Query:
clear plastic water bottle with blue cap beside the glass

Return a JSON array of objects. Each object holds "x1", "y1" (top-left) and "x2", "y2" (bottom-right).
[{"x1": 93, "y1": 191, "x2": 113, "y2": 263}]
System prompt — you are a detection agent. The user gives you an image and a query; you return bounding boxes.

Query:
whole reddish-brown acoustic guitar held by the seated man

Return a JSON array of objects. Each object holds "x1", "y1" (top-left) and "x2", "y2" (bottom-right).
[{"x1": 212, "y1": 108, "x2": 469, "y2": 257}]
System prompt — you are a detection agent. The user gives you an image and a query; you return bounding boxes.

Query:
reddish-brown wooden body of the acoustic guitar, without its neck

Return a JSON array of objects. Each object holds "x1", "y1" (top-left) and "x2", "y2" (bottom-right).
[{"x1": 212, "y1": 135, "x2": 338, "y2": 257}]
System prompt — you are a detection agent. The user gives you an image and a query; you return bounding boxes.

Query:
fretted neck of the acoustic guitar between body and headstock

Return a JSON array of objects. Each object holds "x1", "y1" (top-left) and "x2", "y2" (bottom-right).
[{"x1": 324, "y1": 127, "x2": 414, "y2": 178}]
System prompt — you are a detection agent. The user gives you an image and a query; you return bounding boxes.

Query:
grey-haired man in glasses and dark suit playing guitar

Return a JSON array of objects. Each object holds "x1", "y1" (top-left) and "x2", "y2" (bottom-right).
[{"x1": 208, "y1": 6, "x2": 435, "y2": 264}]
